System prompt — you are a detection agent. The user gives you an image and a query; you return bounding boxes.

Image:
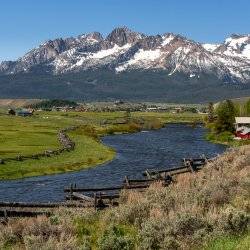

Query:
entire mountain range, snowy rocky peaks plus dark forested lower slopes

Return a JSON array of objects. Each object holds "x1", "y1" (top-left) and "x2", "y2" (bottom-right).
[{"x1": 0, "y1": 27, "x2": 250, "y2": 102}]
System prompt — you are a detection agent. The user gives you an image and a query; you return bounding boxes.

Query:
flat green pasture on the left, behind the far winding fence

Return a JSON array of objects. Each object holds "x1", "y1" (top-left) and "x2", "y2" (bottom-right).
[{"x1": 0, "y1": 115, "x2": 72, "y2": 158}]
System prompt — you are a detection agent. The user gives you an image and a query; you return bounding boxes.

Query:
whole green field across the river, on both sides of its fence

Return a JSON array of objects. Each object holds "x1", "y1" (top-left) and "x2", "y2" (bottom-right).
[{"x1": 0, "y1": 111, "x2": 202, "y2": 179}]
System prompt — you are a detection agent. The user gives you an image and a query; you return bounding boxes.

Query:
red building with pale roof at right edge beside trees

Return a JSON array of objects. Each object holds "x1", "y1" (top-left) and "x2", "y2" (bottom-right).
[{"x1": 235, "y1": 117, "x2": 250, "y2": 139}]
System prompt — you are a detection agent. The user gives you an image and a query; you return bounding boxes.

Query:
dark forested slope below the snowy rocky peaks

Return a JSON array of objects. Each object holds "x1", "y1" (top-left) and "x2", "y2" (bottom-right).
[{"x1": 0, "y1": 70, "x2": 250, "y2": 103}]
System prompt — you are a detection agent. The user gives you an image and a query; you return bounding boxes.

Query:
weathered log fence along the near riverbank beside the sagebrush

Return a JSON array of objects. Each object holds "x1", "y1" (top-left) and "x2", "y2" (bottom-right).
[{"x1": 0, "y1": 154, "x2": 210, "y2": 218}]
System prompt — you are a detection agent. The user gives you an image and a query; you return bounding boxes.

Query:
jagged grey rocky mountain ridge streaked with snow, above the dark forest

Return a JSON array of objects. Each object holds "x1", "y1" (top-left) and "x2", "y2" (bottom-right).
[{"x1": 0, "y1": 27, "x2": 250, "y2": 84}]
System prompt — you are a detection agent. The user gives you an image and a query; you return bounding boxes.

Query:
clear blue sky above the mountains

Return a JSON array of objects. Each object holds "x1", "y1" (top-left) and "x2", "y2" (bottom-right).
[{"x1": 0, "y1": 0, "x2": 250, "y2": 61}]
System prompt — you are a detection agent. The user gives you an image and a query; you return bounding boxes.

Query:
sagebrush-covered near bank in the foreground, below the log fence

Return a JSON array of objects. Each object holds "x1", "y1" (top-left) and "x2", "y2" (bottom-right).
[{"x1": 0, "y1": 141, "x2": 250, "y2": 250}]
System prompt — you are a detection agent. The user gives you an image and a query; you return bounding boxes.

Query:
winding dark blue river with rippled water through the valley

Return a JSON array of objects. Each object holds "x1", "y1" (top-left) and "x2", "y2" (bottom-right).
[{"x1": 0, "y1": 124, "x2": 226, "y2": 202}]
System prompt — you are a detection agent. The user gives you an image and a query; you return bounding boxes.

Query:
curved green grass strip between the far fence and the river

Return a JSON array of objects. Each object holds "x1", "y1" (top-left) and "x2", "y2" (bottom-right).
[{"x1": 0, "y1": 130, "x2": 115, "y2": 179}]
